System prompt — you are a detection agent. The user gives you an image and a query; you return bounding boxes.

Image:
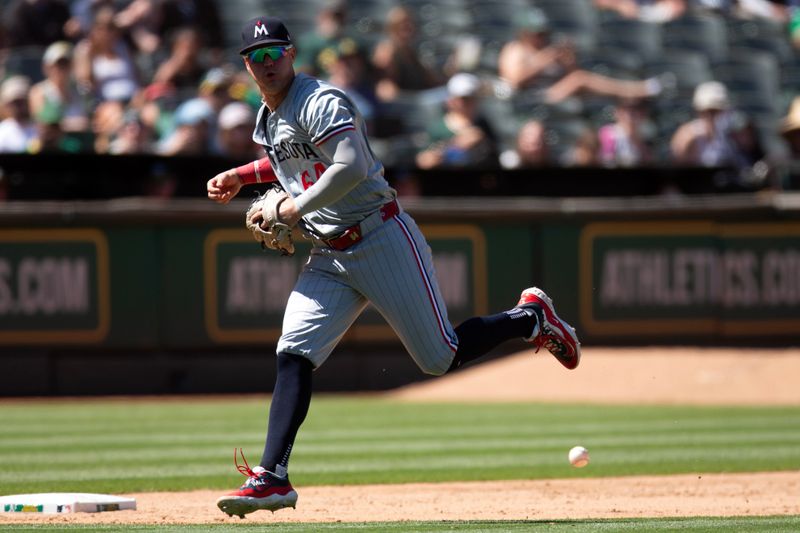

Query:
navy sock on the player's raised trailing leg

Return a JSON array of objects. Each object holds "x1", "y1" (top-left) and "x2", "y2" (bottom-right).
[{"x1": 447, "y1": 308, "x2": 538, "y2": 372}]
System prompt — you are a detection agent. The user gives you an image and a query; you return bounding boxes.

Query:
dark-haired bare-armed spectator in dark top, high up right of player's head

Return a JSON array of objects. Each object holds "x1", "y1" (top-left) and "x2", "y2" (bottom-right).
[{"x1": 372, "y1": 6, "x2": 444, "y2": 101}]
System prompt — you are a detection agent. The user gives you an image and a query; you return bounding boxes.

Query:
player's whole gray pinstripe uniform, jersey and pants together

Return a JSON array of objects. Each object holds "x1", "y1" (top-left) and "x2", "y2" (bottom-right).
[{"x1": 253, "y1": 74, "x2": 458, "y2": 374}]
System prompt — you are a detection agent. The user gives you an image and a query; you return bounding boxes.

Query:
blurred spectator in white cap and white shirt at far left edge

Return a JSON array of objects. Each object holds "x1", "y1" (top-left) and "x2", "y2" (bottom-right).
[{"x1": 0, "y1": 76, "x2": 38, "y2": 153}]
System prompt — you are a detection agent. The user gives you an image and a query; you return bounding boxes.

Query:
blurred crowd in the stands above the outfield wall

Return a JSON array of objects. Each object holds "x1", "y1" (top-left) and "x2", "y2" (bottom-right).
[{"x1": 0, "y1": 0, "x2": 800, "y2": 192}]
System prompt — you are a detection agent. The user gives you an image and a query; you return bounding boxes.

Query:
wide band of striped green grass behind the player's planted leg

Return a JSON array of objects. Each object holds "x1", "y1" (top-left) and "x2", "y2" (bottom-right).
[{"x1": 0, "y1": 391, "x2": 800, "y2": 494}]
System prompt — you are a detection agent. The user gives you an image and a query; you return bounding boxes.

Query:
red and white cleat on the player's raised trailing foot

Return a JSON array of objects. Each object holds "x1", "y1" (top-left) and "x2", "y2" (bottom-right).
[{"x1": 517, "y1": 287, "x2": 581, "y2": 370}]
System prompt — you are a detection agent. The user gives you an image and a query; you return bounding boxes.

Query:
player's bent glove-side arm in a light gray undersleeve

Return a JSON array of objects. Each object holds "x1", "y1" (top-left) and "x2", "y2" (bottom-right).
[{"x1": 280, "y1": 129, "x2": 369, "y2": 226}]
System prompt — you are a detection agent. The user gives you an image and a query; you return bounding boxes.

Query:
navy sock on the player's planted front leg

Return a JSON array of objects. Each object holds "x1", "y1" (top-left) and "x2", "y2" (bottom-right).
[{"x1": 261, "y1": 353, "x2": 313, "y2": 477}]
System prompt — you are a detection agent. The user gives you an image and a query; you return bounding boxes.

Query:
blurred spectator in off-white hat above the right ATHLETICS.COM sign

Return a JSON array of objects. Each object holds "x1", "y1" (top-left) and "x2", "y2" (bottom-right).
[{"x1": 670, "y1": 81, "x2": 764, "y2": 185}]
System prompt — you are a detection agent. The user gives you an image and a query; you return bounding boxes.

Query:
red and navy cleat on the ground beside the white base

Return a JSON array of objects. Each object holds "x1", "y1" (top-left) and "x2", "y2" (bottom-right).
[{"x1": 217, "y1": 446, "x2": 297, "y2": 518}]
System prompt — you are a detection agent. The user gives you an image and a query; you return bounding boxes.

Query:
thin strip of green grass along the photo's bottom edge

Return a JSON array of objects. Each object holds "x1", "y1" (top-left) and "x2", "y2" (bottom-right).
[{"x1": 3, "y1": 516, "x2": 800, "y2": 533}]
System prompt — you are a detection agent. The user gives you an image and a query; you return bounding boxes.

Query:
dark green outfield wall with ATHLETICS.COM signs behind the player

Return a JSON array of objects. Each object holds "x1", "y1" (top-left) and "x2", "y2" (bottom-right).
[{"x1": 0, "y1": 193, "x2": 800, "y2": 394}]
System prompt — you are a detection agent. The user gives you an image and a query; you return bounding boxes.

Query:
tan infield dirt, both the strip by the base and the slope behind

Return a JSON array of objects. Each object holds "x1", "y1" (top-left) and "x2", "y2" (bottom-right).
[{"x1": 0, "y1": 348, "x2": 800, "y2": 524}]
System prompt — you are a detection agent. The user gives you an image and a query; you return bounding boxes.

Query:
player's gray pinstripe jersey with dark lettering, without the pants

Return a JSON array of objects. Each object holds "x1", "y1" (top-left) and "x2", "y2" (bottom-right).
[{"x1": 253, "y1": 73, "x2": 396, "y2": 237}]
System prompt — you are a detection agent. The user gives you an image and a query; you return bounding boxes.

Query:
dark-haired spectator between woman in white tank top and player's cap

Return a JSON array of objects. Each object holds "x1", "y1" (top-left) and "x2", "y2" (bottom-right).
[{"x1": 153, "y1": 27, "x2": 206, "y2": 91}]
